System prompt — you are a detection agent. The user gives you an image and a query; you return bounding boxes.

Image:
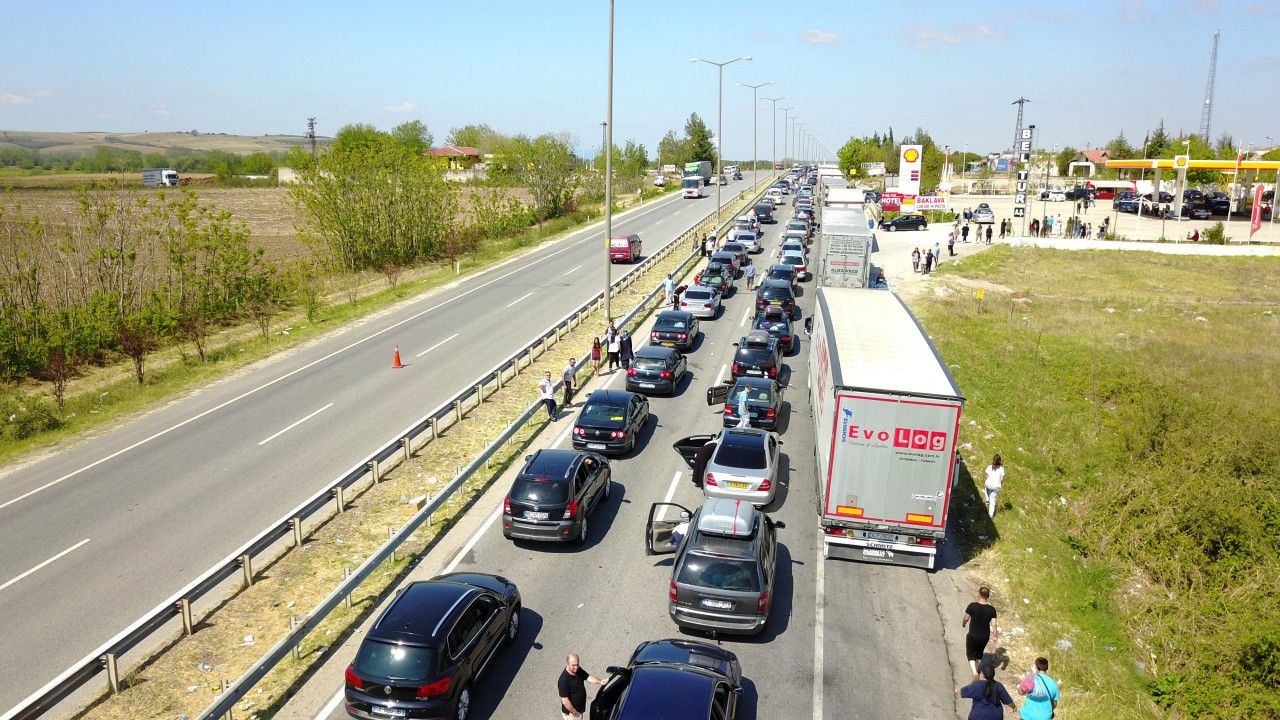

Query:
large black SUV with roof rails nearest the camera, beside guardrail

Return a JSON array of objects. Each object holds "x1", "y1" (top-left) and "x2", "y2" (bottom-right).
[{"x1": 344, "y1": 573, "x2": 520, "y2": 720}]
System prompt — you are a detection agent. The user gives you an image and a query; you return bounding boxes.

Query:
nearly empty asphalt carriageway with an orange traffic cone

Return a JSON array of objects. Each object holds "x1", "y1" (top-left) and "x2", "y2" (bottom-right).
[{"x1": 0, "y1": 181, "x2": 750, "y2": 708}]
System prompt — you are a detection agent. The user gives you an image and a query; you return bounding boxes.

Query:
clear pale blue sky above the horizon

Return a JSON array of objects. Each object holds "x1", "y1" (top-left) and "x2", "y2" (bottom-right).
[{"x1": 0, "y1": 0, "x2": 1280, "y2": 159}]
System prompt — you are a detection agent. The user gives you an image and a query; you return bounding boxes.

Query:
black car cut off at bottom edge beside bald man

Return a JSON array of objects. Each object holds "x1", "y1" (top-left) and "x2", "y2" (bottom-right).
[{"x1": 590, "y1": 639, "x2": 742, "y2": 720}]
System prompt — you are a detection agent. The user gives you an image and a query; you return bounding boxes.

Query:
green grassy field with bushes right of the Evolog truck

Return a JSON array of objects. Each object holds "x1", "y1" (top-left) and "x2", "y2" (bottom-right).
[{"x1": 914, "y1": 247, "x2": 1280, "y2": 719}]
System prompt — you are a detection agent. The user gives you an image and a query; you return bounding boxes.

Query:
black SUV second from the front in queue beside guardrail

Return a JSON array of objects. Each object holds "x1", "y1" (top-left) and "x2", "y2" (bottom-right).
[{"x1": 502, "y1": 450, "x2": 612, "y2": 542}]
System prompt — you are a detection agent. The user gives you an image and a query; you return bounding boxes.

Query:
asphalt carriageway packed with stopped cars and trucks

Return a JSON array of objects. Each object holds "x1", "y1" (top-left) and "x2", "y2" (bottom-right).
[{"x1": 293, "y1": 196, "x2": 956, "y2": 720}]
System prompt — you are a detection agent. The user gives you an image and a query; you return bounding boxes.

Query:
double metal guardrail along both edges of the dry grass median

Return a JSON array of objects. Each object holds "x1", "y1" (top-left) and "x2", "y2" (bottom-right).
[{"x1": 0, "y1": 175, "x2": 768, "y2": 720}]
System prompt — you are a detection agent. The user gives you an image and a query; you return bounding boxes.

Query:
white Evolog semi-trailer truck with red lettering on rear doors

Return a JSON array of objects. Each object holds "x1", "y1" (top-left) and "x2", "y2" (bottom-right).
[{"x1": 805, "y1": 287, "x2": 964, "y2": 570}]
